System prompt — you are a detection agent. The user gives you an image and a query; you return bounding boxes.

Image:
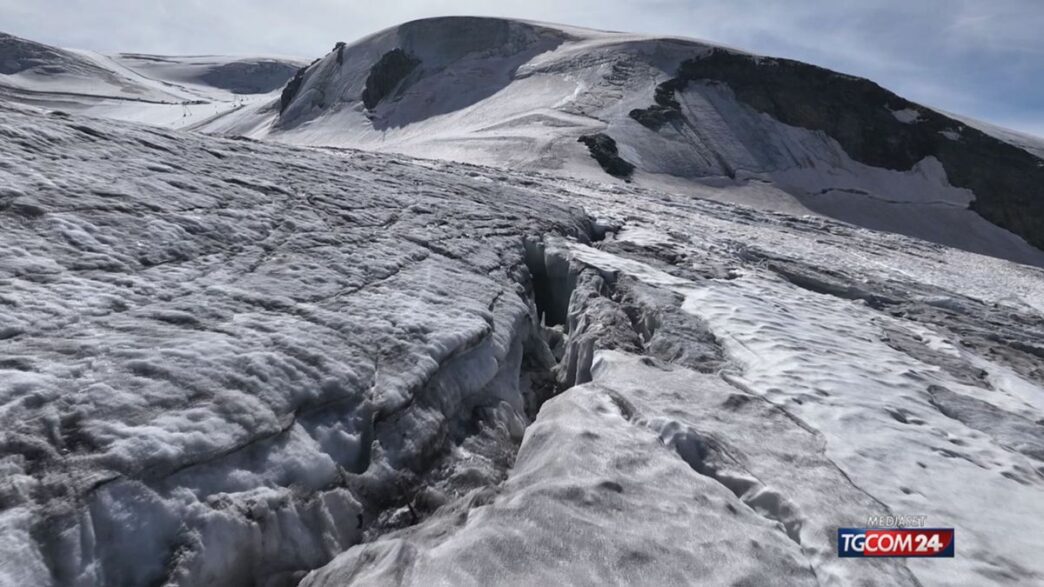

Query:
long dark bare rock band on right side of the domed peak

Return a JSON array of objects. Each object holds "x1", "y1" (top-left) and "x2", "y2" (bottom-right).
[{"x1": 631, "y1": 50, "x2": 1044, "y2": 248}]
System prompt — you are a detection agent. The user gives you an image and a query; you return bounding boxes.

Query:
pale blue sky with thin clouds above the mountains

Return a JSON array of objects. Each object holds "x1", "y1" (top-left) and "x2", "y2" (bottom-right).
[{"x1": 6, "y1": 0, "x2": 1044, "y2": 137}]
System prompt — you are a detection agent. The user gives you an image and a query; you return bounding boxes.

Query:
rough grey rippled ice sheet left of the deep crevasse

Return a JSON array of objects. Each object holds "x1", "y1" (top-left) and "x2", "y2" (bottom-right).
[{"x1": 0, "y1": 105, "x2": 589, "y2": 585}]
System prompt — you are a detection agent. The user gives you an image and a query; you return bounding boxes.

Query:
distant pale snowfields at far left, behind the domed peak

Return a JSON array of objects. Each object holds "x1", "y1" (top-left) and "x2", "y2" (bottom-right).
[{"x1": 0, "y1": 33, "x2": 304, "y2": 127}]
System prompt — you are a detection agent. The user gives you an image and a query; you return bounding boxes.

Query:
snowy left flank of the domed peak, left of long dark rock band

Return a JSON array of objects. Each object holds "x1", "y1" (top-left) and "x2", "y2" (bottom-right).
[{"x1": 197, "y1": 18, "x2": 743, "y2": 171}]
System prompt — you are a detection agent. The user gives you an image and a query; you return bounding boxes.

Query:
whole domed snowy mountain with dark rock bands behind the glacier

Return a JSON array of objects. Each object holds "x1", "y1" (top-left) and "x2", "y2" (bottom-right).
[{"x1": 198, "y1": 18, "x2": 1044, "y2": 265}]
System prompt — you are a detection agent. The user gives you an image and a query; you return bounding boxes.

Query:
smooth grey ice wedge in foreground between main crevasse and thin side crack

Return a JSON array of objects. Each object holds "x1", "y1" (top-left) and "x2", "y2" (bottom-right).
[{"x1": 303, "y1": 369, "x2": 815, "y2": 586}]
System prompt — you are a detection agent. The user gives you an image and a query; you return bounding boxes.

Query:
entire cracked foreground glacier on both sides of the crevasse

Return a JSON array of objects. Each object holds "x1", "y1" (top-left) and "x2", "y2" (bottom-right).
[{"x1": 0, "y1": 95, "x2": 1044, "y2": 587}]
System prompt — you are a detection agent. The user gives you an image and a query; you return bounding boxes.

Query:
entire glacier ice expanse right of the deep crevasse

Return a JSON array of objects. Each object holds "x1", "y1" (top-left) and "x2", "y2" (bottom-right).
[{"x1": 303, "y1": 214, "x2": 1044, "y2": 586}]
